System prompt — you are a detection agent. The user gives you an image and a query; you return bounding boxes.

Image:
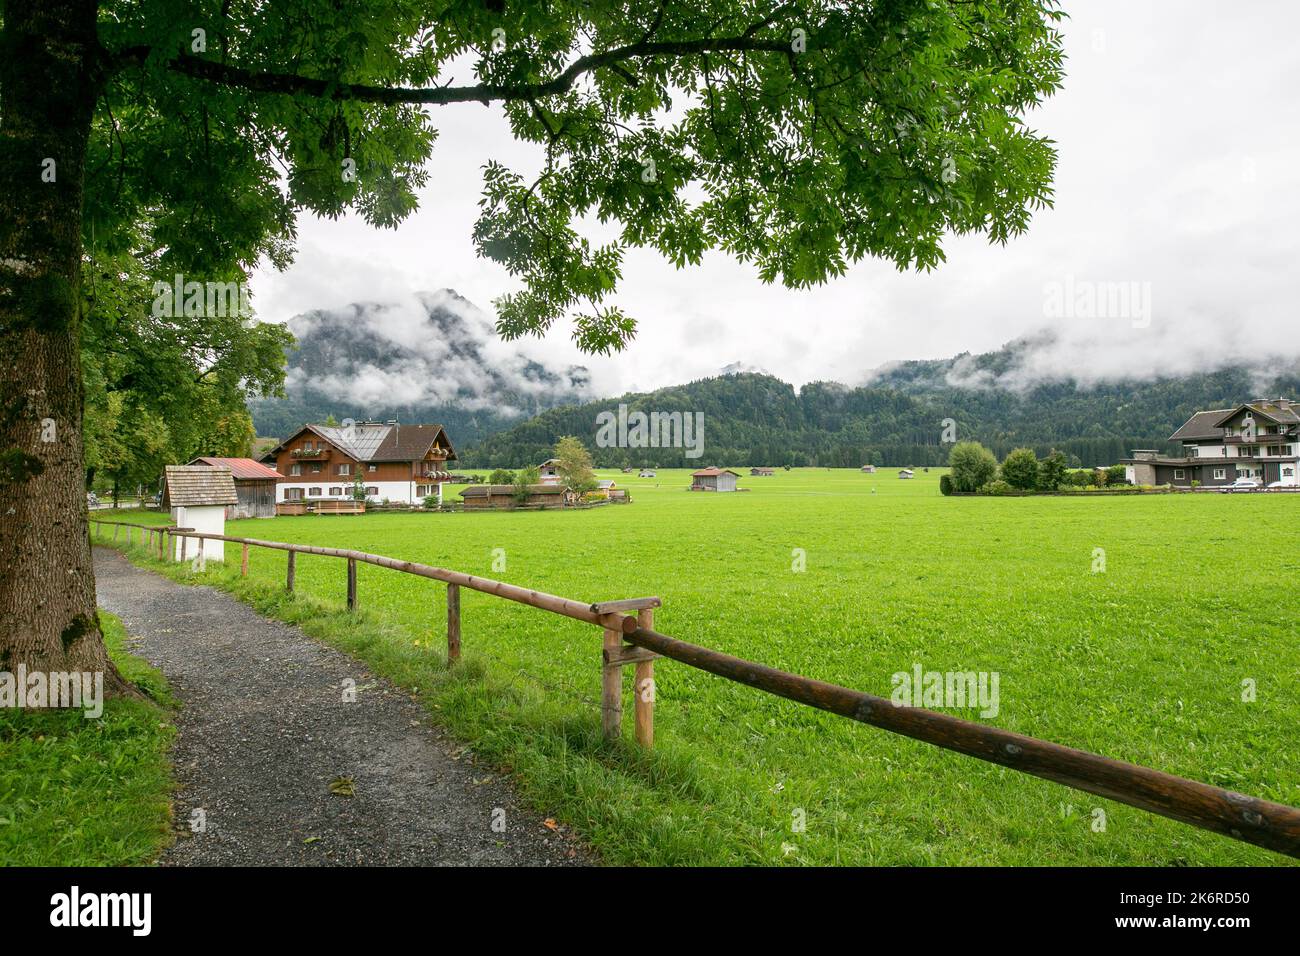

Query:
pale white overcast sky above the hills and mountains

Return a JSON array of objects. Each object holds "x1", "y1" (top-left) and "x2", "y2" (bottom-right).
[{"x1": 254, "y1": 0, "x2": 1300, "y2": 394}]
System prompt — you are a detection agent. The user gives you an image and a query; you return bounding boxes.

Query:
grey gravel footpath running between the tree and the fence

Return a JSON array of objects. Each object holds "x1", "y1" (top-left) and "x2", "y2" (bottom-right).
[{"x1": 95, "y1": 548, "x2": 593, "y2": 866}]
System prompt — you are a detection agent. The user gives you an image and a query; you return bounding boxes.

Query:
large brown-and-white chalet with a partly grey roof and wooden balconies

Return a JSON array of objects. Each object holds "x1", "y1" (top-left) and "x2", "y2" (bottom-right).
[{"x1": 264, "y1": 421, "x2": 456, "y2": 505}]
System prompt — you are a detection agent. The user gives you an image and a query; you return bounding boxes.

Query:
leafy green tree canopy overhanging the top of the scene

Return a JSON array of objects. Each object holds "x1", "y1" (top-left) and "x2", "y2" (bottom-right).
[{"x1": 94, "y1": 0, "x2": 1062, "y2": 351}]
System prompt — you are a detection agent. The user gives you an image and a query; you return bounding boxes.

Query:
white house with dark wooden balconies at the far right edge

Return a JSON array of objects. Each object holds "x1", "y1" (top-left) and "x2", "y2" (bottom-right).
[{"x1": 1123, "y1": 398, "x2": 1300, "y2": 488}]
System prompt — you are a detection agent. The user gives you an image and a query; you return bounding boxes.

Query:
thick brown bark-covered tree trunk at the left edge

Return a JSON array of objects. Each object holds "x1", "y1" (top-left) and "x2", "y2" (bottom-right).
[{"x1": 0, "y1": 0, "x2": 135, "y2": 696}]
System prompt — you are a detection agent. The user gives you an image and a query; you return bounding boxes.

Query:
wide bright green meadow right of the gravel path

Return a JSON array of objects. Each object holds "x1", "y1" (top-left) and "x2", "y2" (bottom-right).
[{"x1": 94, "y1": 468, "x2": 1300, "y2": 865}]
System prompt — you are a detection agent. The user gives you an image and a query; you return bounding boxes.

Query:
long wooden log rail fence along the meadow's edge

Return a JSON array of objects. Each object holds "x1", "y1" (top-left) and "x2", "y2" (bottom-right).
[{"x1": 90, "y1": 518, "x2": 1300, "y2": 858}]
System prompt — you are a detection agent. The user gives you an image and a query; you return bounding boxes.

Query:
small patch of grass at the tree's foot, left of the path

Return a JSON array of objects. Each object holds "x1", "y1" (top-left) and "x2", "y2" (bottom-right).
[{"x1": 0, "y1": 611, "x2": 174, "y2": 866}]
